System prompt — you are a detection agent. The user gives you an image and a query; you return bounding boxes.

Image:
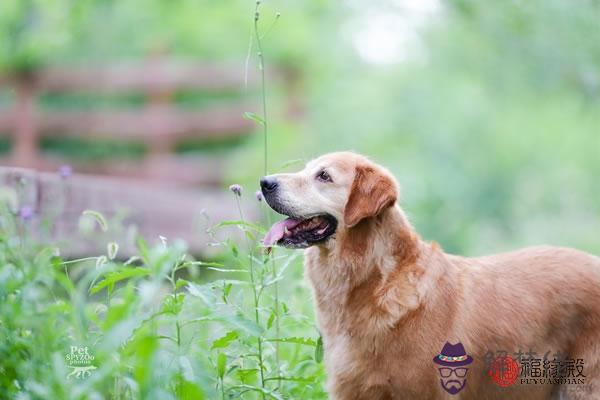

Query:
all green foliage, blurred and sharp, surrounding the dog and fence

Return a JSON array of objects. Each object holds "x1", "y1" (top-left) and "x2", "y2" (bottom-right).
[{"x1": 0, "y1": 0, "x2": 600, "y2": 399}]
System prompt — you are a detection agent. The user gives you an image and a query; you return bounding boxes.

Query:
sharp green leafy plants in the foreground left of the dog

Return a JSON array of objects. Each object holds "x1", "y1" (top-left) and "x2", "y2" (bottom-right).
[{"x1": 0, "y1": 2, "x2": 326, "y2": 399}]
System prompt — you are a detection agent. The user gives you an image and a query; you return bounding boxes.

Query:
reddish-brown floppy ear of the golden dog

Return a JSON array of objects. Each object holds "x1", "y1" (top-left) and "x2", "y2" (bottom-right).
[{"x1": 344, "y1": 165, "x2": 398, "y2": 228}]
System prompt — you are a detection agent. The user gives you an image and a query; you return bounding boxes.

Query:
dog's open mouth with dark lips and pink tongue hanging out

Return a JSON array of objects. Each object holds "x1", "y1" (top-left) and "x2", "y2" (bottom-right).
[{"x1": 263, "y1": 214, "x2": 337, "y2": 249}]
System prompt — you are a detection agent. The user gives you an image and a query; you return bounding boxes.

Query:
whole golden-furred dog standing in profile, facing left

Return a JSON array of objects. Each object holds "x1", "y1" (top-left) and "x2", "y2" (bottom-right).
[{"x1": 260, "y1": 152, "x2": 600, "y2": 400}]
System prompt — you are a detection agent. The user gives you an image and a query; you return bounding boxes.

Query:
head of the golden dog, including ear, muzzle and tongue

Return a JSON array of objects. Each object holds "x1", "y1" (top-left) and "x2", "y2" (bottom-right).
[{"x1": 260, "y1": 152, "x2": 398, "y2": 248}]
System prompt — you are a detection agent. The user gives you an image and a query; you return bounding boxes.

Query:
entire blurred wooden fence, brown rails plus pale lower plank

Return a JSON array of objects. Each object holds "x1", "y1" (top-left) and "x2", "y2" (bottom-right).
[{"x1": 0, "y1": 58, "x2": 274, "y2": 254}]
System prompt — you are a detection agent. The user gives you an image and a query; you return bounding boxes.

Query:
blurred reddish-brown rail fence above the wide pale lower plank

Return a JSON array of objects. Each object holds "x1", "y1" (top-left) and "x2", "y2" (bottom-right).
[{"x1": 0, "y1": 58, "x2": 264, "y2": 184}]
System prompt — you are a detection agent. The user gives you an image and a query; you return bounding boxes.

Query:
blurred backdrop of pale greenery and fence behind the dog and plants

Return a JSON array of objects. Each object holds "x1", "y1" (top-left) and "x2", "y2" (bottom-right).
[{"x1": 0, "y1": 0, "x2": 600, "y2": 255}]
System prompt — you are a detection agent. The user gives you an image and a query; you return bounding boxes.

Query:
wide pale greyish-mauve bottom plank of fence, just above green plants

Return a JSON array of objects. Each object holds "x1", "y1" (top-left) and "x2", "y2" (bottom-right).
[{"x1": 0, "y1": 167, "x2": 259, "y2": 257}]
